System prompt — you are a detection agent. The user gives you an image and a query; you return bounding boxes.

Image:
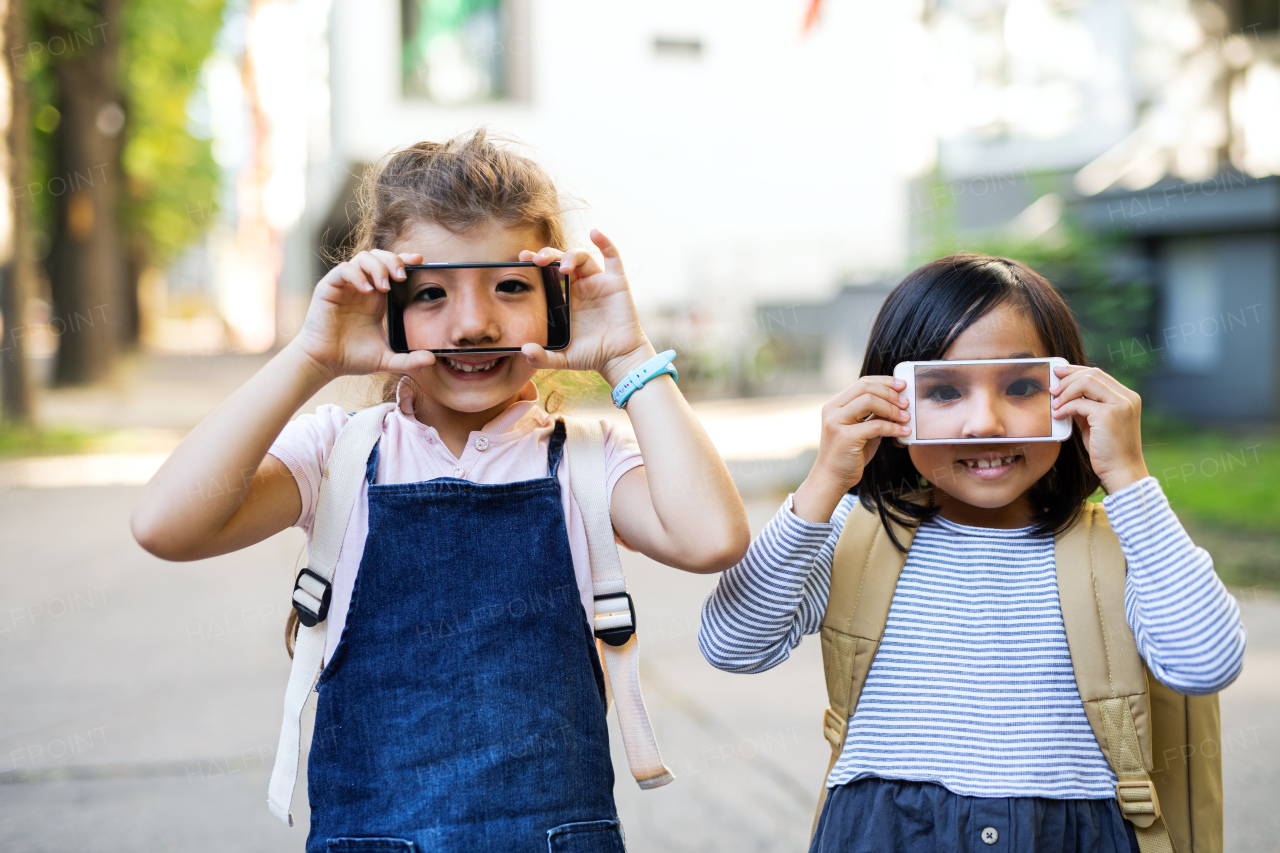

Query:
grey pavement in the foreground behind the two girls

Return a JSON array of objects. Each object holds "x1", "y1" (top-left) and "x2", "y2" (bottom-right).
[{"x1": 0, "y1": 487, "x2": 1280, "y2": 853}]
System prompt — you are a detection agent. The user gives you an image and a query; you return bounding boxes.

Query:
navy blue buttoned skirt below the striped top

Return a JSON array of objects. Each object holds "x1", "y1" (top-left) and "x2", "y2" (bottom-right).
[{"x1": 809, "y1": 779, "x2": 1138, "y2": 853}]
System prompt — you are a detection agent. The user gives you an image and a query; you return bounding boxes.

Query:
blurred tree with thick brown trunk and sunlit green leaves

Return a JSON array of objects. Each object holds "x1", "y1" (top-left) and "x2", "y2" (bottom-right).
[{"x1": 23, "y1": 0, "x2": 224, "y2": 384}]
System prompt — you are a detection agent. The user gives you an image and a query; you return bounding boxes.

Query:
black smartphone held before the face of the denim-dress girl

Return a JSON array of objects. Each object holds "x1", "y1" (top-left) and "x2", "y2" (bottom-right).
[{"x1": 387, "y1": 263, "x2": 570, "y2": 353}]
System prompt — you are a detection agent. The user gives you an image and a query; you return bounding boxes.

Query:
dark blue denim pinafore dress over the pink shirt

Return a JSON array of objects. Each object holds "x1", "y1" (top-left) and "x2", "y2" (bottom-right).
[{"x1": 307, "y1": 424, "x2": 622, "y2": 853}]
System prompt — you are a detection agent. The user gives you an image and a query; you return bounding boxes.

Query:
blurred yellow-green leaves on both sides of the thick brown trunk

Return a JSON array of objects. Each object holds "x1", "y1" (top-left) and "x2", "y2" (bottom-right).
[{"x1": 19, "y1": 0, "x2": 224, "y2": 265}]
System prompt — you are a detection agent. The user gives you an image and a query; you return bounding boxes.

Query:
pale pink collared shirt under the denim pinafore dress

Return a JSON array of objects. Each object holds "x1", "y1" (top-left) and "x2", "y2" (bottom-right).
[{"x1": 268, "y1": 380, "x2": 644, "y2": 662}]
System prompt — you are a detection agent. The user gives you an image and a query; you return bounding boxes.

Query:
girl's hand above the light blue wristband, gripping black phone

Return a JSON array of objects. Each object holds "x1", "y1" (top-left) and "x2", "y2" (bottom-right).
[{"x1": 520, "y1": 229, "x2": 655, "y2": 386}]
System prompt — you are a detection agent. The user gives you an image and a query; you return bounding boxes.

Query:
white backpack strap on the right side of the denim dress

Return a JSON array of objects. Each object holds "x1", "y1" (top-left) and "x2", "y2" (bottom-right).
[{"x1": 564, "y1": 418, "x2": 675, "y2": 790}]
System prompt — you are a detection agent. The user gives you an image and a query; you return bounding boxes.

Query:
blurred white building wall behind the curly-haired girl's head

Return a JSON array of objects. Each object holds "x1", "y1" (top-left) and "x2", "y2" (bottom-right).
[{"x1": 308, "y1": 0, "x2": 923, "y2": 307}]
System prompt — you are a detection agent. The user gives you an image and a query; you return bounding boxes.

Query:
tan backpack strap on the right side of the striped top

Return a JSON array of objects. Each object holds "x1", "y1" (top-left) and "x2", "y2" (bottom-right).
[{"x1": 1053, "y1": 503, "x2": 1174, "y2": 853}]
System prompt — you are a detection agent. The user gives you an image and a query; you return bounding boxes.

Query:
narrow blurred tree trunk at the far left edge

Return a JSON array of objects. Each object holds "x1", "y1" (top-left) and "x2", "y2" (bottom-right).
[{"x1": 0, "y1": 0, "x2": 36, "y2": 425}]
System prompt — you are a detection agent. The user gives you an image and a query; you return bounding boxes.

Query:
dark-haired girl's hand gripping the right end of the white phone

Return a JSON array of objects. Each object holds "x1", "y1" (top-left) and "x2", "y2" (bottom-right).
[{"x1": 1053, "y1": 364, "x2": 1148, "y2": 493}]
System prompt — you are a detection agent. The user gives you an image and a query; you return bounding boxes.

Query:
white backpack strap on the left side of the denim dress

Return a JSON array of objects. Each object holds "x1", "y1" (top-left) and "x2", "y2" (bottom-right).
[{"x1": 266, "y1": 403, "x2": 396, "y2": 826}]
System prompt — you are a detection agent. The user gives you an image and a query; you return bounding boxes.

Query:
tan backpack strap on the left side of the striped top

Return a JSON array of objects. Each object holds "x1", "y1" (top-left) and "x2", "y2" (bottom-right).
[{"x1": 814, "y1": 503, "x2": 915, "y2": 827}]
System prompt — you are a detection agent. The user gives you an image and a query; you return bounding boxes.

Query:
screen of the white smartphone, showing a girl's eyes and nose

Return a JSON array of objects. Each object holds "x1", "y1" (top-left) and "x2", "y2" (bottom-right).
[{"x1": 914, "y1": 361, "x2": 1053, "y2": 441}]
